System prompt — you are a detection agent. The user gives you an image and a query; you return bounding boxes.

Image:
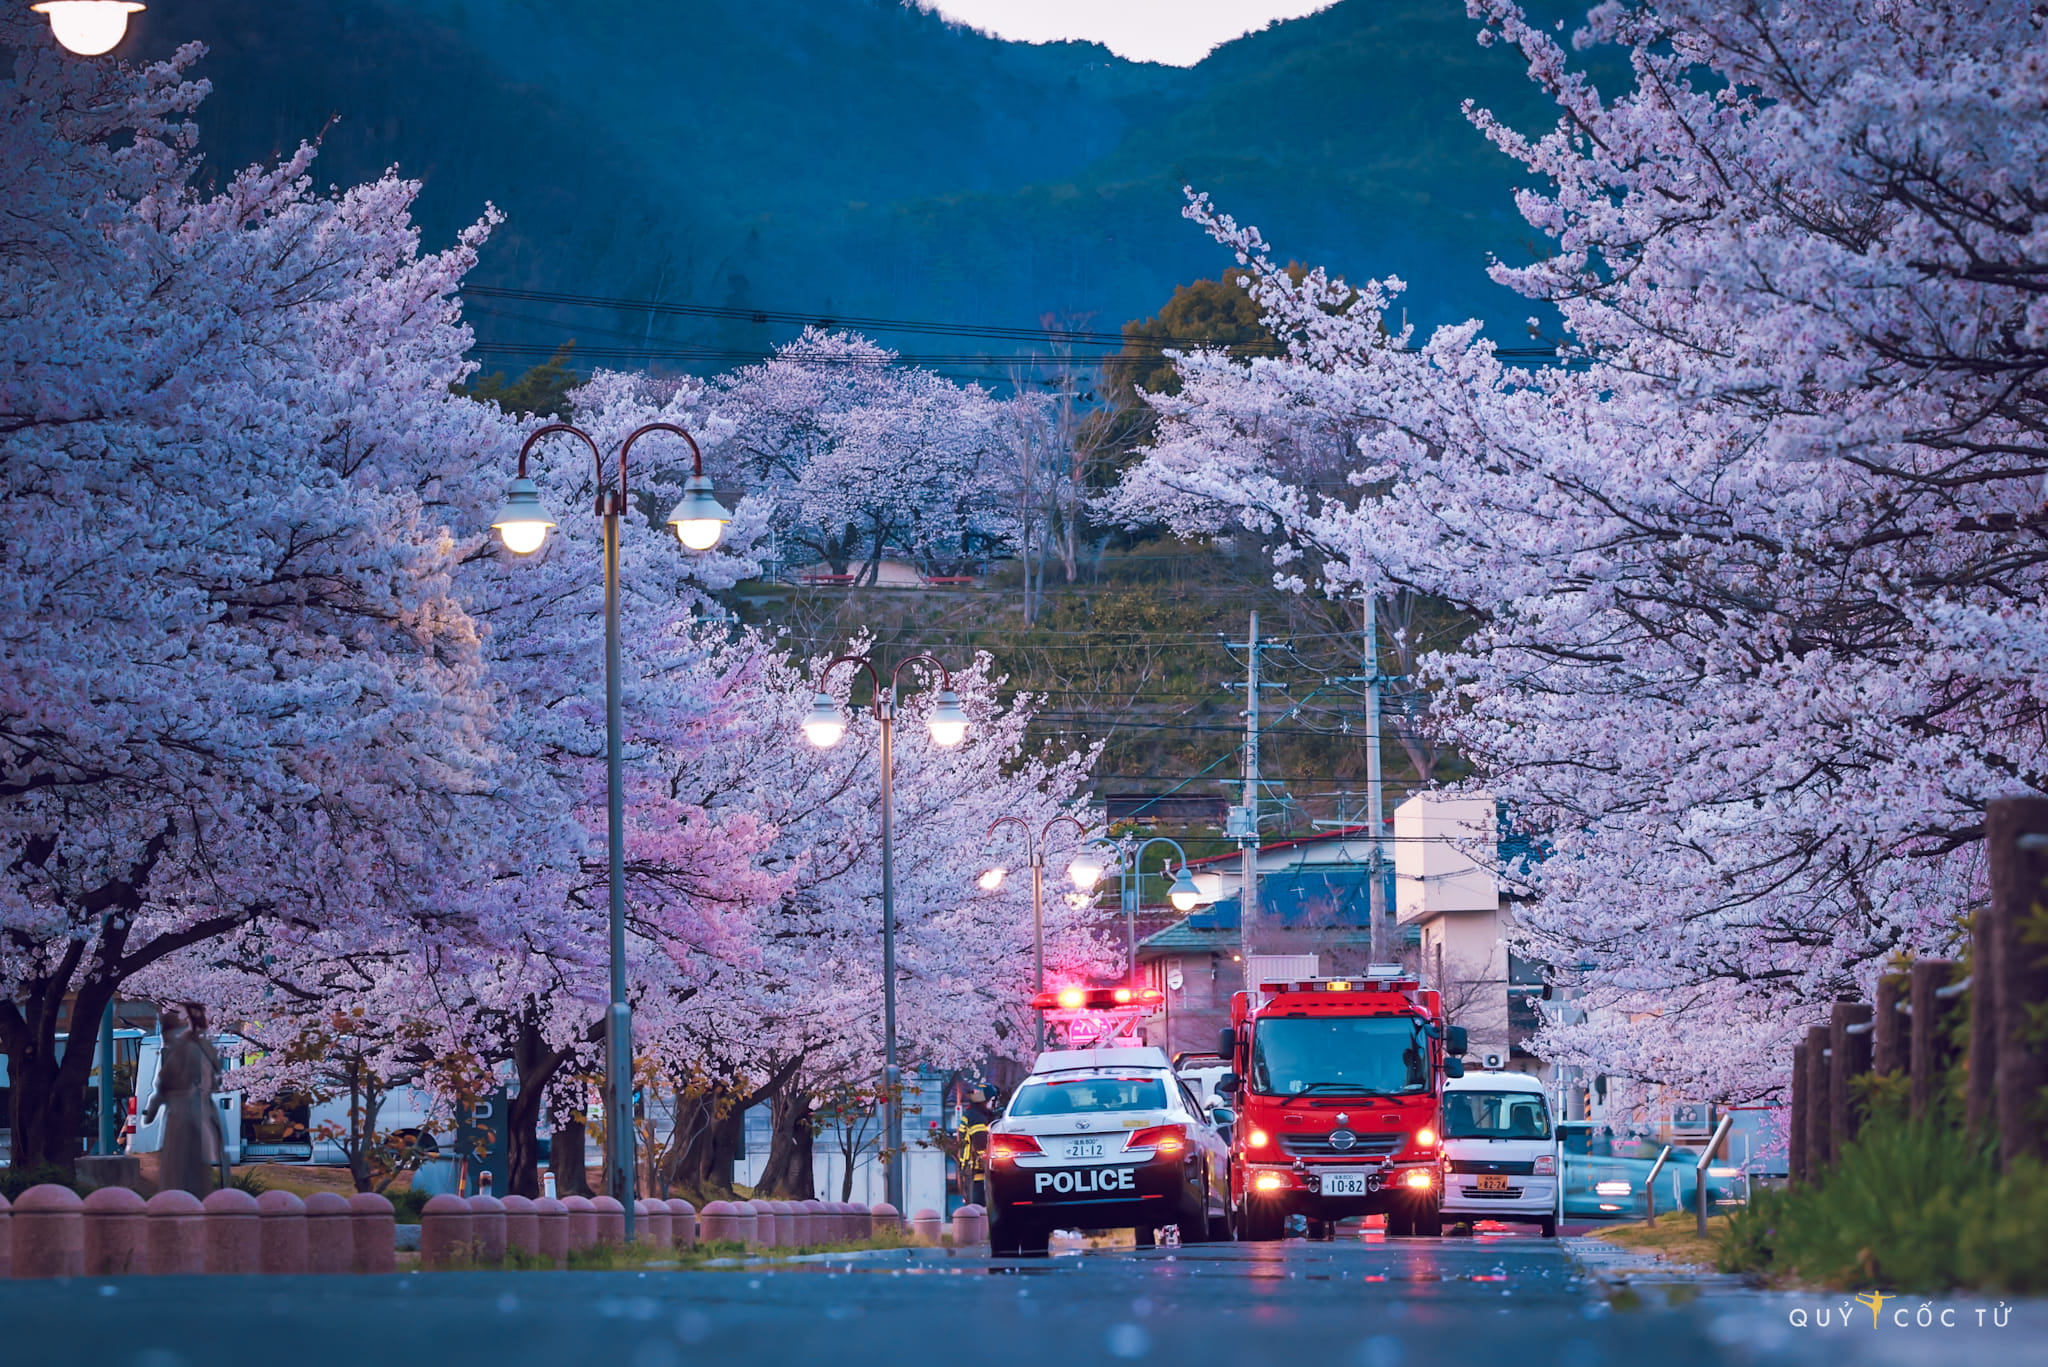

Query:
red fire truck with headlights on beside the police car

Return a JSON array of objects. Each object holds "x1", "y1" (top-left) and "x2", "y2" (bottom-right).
[{"x1": 1217, "y1": 967, "x2": 1464, "y2": 1240}]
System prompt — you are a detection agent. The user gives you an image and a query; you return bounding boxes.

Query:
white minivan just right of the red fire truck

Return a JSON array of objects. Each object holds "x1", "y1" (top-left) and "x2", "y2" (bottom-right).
[{"x1": 1444, "y1": 1072, "x2": 1559, "y2": 1238}]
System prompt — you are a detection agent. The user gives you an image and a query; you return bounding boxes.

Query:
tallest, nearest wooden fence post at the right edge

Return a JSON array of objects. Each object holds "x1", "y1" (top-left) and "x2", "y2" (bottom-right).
[{"x1": 1970, "y1": 797, "x2": 2048, "y2": 1164}]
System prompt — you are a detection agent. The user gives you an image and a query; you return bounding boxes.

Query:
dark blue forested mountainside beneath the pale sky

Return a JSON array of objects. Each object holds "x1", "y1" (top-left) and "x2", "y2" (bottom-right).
[{"x1": 108, "y1": 0, "x2": 1581, "y2": 366}]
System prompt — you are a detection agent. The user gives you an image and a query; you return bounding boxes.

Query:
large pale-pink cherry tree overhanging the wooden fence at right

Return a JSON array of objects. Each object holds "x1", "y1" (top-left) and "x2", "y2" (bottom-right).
[{"x1": 1124, "y1": 0, "x2": 2048, "y2": 1101}]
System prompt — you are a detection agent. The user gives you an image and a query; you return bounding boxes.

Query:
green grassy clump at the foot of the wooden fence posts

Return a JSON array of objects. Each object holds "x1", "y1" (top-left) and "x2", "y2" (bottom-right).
[{"x1": 1718, "y1": 1117, "x2": 2048, "y2": 1293}]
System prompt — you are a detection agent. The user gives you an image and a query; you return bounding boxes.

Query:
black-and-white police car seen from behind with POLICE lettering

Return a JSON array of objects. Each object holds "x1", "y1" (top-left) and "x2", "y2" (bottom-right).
[{"x1": 987, "y1": 1045, "x2": 1231, "y2": 1256}]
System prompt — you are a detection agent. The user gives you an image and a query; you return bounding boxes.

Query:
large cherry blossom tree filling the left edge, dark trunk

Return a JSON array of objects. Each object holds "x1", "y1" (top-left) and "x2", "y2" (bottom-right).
[{"x1": 0, "y1": 12, "x2": 561, "y2": 1164}]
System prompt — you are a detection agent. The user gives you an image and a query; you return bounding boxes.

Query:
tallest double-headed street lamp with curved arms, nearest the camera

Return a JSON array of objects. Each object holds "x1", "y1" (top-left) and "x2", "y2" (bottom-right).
[{"x1": 492, "y1": 422, "x2": 733, "y2": 1242}]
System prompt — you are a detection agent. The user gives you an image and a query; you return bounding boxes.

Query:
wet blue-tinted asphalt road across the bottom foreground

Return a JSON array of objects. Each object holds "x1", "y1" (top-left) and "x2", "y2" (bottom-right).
[{"x1": 0, "y1": 1236, "x2": 2048, "y2": 1367}]
